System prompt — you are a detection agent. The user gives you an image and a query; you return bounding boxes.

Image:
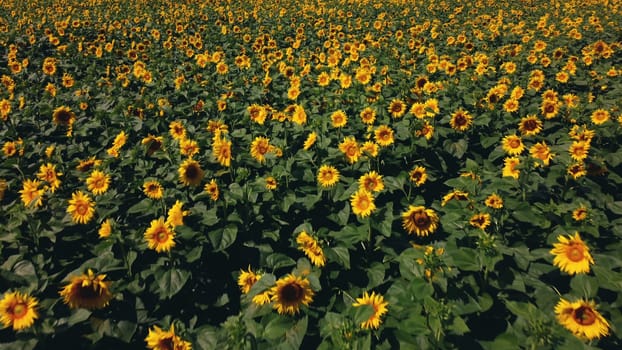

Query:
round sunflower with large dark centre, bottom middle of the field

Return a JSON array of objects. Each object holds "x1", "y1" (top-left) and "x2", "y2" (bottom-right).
[{"x1": 270, "y1": 274, "x2": 314, "y2": 315}]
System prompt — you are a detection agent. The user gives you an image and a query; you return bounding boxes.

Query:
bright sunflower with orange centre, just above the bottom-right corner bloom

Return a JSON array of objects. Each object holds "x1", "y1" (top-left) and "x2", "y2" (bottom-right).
[{"x1": 550, "y1": 232, "x2": 594, "y2": 275}]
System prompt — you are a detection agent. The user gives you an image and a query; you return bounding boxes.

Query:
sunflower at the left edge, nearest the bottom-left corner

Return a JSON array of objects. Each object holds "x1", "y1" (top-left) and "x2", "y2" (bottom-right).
[{"x1": 0, "y1": 292, "x2": 39, "y2": 331}]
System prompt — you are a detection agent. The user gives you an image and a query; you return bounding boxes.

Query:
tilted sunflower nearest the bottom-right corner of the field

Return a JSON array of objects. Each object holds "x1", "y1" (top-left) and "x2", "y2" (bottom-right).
[{"x1": 555, "y1": 299, "x2": 609, "y2": 340}]
